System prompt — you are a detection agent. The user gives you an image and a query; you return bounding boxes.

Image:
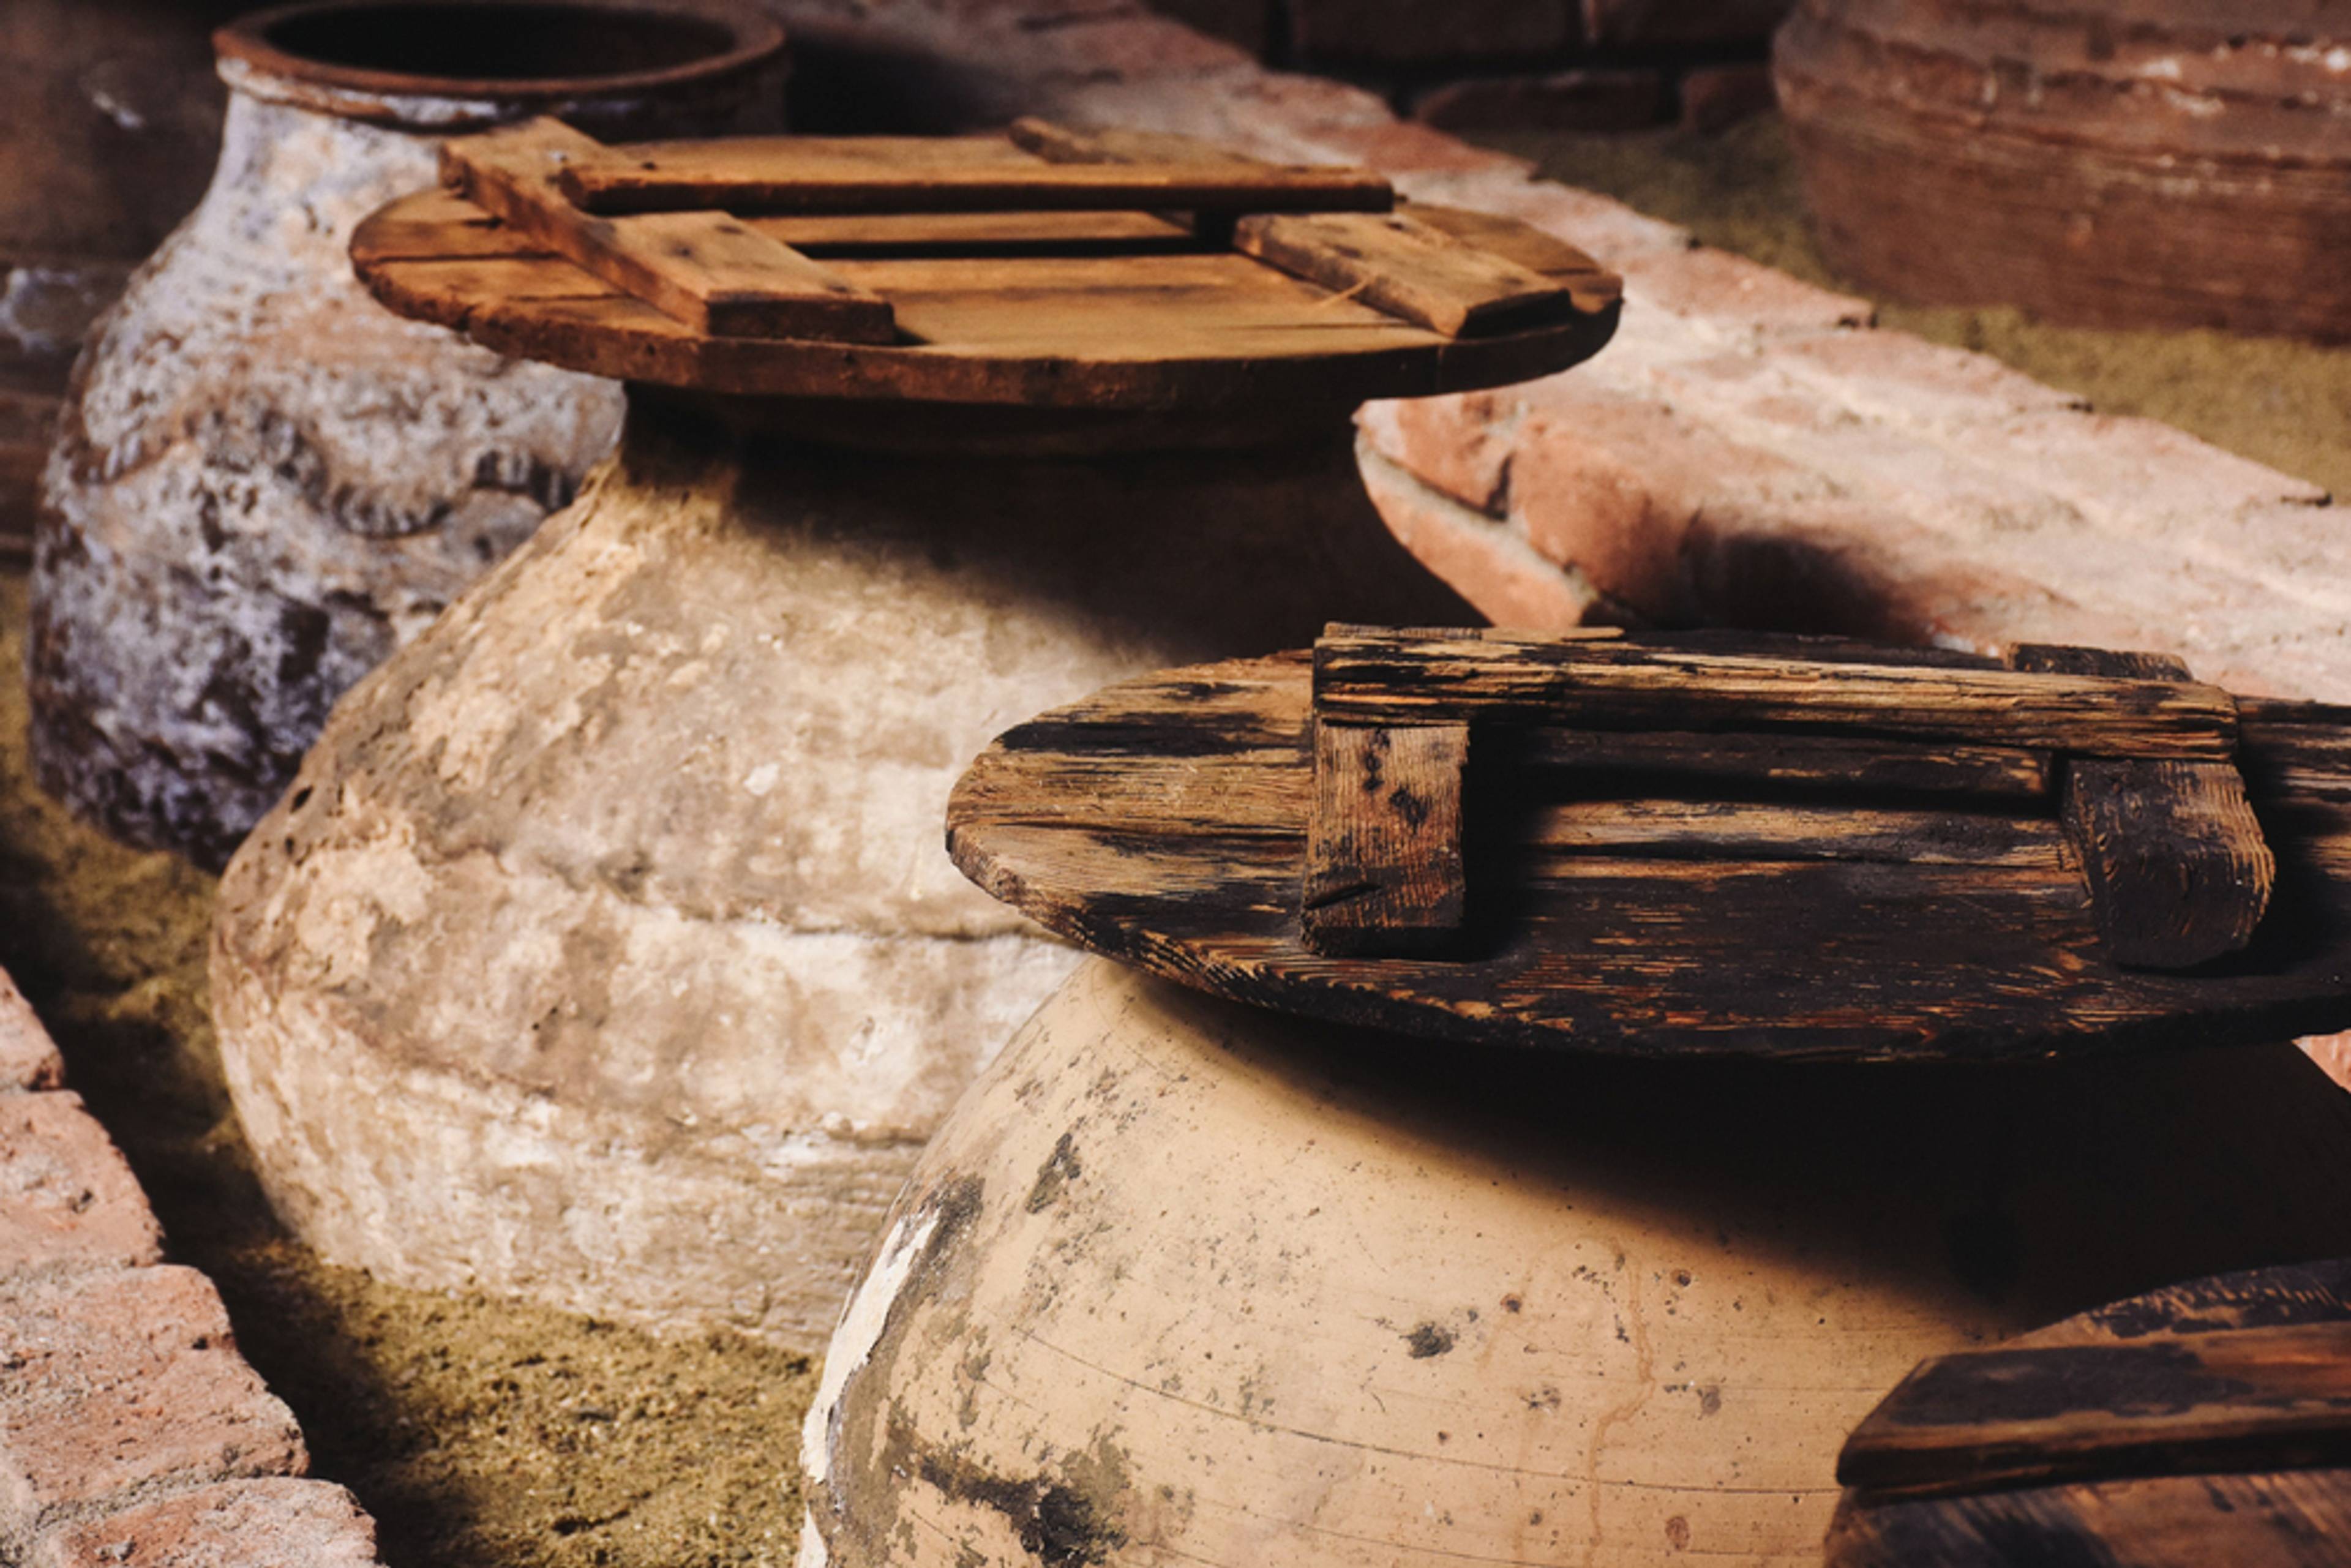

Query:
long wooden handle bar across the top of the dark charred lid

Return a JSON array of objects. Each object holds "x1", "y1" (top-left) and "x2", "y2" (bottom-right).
[{"x1": 1314, "y1": 630, "x2": 2236, "y2": 759}]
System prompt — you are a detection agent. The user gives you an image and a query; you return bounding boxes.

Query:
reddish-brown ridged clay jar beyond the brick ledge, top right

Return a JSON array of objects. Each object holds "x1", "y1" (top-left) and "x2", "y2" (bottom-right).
[{"x1": 1772, "y1": 0, "x2": 2351, "y2": 341}]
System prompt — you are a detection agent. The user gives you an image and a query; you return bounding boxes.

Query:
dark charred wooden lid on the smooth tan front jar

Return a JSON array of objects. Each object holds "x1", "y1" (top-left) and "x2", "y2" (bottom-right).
[{"x1": 948, "y1": 628, "x2": 2351, "y2": 1058}]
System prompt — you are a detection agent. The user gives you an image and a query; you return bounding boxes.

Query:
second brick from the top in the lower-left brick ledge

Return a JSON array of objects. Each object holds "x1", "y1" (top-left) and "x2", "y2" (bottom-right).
[{"x1": 0, "y1": 1091, "x2": 162, "y2": 1279}]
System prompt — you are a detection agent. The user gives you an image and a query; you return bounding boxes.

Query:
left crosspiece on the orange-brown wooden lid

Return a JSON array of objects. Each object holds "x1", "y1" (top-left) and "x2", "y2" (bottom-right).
[{"x1": 442, "y1": 120, "x2": 898, "y2": 343}]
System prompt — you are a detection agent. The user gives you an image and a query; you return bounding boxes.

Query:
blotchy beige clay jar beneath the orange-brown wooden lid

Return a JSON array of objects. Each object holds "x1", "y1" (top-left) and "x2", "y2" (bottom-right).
[{"x1": 212, "y1": 388, "x2": 1467, "y2": 1349}]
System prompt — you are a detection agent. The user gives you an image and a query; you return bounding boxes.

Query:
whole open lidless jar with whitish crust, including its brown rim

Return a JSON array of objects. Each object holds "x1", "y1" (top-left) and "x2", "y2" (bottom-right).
[{"x1": 28, "y1": 0, "x2": 783, "y2": 865}]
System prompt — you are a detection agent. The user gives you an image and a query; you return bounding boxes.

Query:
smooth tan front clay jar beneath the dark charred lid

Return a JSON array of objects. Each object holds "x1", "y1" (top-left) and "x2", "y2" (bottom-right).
[{"x1": 800, "y1": 961, "x2": 2351, "y2": 1568}]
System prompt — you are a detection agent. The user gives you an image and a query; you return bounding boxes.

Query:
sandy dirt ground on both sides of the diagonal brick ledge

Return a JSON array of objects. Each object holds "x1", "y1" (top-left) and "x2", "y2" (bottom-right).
[{"x1": 0, "y1": 103, "x2": 2351, "y2": 1568}]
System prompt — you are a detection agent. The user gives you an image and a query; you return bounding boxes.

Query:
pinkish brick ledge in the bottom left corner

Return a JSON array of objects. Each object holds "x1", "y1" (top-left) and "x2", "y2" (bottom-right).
[{"x1": 0, "y1": 973, "x2": 390, "y2": 1568}]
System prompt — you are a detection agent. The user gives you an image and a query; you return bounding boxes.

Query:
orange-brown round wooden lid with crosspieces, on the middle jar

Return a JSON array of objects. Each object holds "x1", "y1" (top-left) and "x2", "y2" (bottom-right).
[{"x1": 350, "y1": 120, "x2": 1618, "y2": 409}]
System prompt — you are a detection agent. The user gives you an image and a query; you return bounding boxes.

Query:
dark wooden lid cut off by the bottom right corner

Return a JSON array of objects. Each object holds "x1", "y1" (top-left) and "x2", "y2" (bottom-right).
[{"x1": 1827, "y1": 1260, "x2": 2351, "y2": 1568}]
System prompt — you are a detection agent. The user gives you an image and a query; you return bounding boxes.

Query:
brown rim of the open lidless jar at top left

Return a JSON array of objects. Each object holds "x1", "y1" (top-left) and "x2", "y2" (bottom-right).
[{"x1": 212, "y1": 0, "x2": 786, "y2": 129}]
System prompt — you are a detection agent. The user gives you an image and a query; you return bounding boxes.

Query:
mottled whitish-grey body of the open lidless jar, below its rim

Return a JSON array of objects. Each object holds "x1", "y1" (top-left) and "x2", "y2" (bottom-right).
[{"x1": 28, "y1": 94, "x2": 621, "y2": 865}]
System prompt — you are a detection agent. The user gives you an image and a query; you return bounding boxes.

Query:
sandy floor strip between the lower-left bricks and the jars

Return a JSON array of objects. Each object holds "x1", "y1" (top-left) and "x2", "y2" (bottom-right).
[{"x1": 0, "y1": 569, "x2": 814, "y2": 1568}]
